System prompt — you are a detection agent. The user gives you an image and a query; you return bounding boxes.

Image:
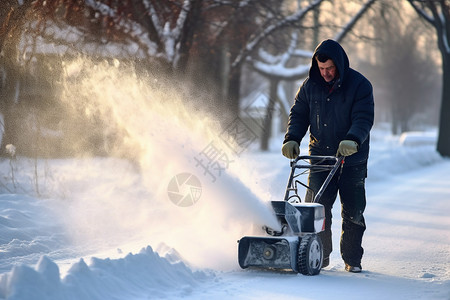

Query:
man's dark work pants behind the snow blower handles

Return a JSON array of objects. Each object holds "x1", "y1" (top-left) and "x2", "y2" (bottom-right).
[{"x1": 306, "y1": 163, "x2": 367, "y2": 266}]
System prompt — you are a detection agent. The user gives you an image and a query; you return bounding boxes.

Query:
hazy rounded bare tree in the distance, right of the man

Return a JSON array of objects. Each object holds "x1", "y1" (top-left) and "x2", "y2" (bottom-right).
[{"x1": 366, "y1": 3, "x2": 440, "y2": 134}]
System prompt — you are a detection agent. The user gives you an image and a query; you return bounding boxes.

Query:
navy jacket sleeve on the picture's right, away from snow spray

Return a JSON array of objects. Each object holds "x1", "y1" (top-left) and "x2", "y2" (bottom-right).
[{"x1": 346, "y1": 79, "x2": 374, "y2": 146}]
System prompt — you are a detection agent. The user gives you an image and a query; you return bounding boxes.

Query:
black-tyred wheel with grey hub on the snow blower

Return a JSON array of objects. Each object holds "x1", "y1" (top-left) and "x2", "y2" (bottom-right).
[{"x1": 298, "y1": 234, "x2": 323, "y2": 276}]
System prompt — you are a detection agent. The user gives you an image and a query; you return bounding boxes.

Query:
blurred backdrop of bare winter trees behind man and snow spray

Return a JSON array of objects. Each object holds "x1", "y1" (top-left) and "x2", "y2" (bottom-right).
[{"x1": 0, "y1": 0, "x2": 450, "y2": 157}]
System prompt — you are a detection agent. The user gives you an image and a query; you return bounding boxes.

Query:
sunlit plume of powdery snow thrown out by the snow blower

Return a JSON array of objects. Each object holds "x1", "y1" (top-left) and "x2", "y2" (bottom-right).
[{"x1": 55, "y1": 59, "x2": 279, "y2": 269}]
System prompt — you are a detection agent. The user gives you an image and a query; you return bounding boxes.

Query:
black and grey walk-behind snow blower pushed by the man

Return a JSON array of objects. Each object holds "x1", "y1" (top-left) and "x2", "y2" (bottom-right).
[{"x1": 238, "y1": 156, "x2": 344, "y2": 275}]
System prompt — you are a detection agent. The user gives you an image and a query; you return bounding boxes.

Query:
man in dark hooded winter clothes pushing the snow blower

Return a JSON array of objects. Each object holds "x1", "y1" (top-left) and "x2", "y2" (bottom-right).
[{"x1": 282, "y1": 40, "x2": 374, "y2": 273}]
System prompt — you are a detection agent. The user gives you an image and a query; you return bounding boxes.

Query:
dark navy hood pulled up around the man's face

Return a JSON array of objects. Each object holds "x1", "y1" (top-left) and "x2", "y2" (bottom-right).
[{"x1": 309, "y1": 40, "x2": 349, "y2": 83}]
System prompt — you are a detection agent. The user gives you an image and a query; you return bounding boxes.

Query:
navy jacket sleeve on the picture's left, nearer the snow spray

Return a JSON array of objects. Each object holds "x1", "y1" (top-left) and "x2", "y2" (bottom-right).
[{"x1": 283, "y1": 83, "x2": 309, "y2": 144}]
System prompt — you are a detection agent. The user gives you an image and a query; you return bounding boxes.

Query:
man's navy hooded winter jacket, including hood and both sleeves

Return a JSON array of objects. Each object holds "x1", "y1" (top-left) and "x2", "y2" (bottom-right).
[{"x1": 284, "y1": 40, "x2": 374, "y2": 165}]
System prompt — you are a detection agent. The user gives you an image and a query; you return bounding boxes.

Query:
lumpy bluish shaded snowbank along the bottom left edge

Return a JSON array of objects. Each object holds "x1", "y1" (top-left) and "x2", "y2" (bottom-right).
[{"x1": 0, "y1": 246, "x2": 208, "y2": 300}]
